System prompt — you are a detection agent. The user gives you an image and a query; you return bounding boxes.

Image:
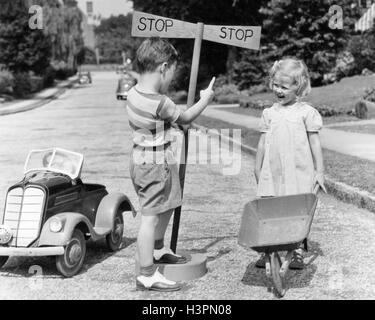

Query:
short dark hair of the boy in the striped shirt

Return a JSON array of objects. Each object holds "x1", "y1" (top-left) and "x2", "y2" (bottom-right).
[{"x1": 134, "y1": 38, "x2": 178, "y2": 74}]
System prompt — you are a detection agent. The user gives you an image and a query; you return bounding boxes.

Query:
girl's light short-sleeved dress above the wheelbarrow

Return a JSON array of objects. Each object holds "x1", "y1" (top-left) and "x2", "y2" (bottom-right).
[{"x1": 257, "y1": 102, "x2": 322, "y2": 197}]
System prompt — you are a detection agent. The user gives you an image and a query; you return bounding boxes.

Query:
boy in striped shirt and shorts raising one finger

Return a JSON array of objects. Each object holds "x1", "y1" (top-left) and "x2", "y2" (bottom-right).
[{"x1": 127, "y1": 38, "x2": 215, "y2": 291}]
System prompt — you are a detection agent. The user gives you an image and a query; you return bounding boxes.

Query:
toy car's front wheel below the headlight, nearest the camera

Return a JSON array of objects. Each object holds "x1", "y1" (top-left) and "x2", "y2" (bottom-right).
[{"x1": 56, "y1": 229, "x2": 86, "y2": 278}]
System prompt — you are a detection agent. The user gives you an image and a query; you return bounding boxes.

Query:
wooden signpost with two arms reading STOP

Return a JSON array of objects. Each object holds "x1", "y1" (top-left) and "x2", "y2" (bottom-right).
[{"x1": 132, "y1": 11, "x2": 261, "y2": 252}]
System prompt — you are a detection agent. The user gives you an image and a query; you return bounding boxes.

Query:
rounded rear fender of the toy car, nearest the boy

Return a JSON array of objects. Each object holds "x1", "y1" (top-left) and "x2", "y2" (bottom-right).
[{"x1": 95, "y1": 193, "x2": 137, "y2": 229}]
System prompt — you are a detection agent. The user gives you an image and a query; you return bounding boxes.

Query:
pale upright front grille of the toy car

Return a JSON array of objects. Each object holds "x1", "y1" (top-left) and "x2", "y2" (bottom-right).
[{"x1": 4, "y1": 187, "x2": 45, "y2": 247}]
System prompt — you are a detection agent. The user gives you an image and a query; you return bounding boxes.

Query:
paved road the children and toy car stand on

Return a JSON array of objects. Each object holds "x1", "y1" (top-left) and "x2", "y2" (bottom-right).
[{"x1": 0, "y1": 73, "x2": 375, "y2": 300}]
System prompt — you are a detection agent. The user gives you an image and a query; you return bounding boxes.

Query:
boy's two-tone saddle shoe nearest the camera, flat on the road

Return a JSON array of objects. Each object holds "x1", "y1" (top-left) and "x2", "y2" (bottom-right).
[{"x1": 136, "y1": 269, "x2": 181, "y2": 292}]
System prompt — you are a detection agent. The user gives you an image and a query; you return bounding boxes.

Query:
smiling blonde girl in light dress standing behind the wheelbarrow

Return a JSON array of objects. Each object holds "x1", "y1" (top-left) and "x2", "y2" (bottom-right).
[{"x1": 255, "y1": 58, "x2": 326, "y2": 269}]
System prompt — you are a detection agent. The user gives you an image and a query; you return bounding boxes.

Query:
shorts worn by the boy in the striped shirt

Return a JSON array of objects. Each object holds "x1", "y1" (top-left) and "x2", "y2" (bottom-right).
[{"x1": 129, "y1": 147, "x2": 182, "y2": 215}]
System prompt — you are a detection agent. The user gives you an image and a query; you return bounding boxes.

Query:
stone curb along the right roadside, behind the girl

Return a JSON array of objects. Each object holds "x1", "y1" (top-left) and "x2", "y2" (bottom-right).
[{"x1": 192, "y1": 124, "x2": 375, "y2": 213}]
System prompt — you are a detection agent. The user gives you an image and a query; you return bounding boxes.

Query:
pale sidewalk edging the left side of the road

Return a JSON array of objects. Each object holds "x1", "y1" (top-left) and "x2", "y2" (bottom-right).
[{"x1": 0, "y1": 75, "x2": 78, "y2": 116}]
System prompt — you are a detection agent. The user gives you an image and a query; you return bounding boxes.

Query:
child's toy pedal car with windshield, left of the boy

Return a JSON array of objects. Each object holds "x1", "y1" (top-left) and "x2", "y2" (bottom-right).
[{"x1": 0, "y1": 148, "x2": 136, "y2": 277}]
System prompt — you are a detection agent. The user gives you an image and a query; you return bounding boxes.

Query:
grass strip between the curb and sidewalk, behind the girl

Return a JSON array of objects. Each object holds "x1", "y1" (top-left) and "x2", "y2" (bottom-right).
[{"x1": 195, "y1": 116, "x2": 375, "y2": 194}]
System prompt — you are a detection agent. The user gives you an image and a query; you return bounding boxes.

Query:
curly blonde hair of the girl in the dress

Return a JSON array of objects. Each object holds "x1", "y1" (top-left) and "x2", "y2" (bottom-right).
[{"x1": 269, "y1": 58, "x2": 311, "y2": 97}]
